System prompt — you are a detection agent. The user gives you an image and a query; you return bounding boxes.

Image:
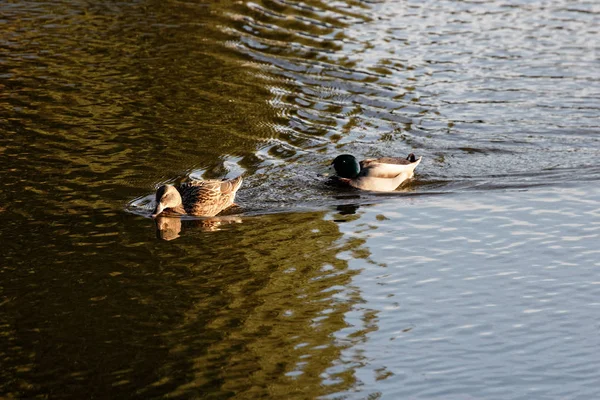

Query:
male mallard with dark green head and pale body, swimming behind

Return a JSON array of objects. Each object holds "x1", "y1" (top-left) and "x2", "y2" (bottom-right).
[{"x1": 332, "y1": 153, "x2": 422, "y2": 192}]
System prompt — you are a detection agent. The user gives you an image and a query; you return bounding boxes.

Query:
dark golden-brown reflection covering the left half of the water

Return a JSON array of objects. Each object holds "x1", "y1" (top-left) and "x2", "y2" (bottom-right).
[{"x1": 0, "y1": 1, "x2": 380, "y2": 398}]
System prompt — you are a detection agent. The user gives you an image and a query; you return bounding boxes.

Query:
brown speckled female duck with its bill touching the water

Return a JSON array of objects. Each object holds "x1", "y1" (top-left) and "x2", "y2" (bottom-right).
[{"x1": 152, "y1": 176, "x2": 242, "y2": 218}]
